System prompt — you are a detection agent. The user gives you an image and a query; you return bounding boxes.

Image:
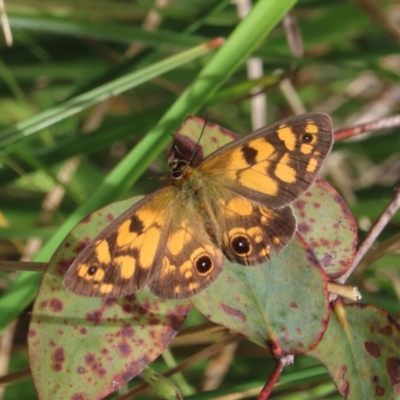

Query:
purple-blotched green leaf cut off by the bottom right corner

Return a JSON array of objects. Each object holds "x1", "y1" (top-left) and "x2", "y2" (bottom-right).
[{"x1": 309, "y1": 300, "x2": 400, "y2": 400}]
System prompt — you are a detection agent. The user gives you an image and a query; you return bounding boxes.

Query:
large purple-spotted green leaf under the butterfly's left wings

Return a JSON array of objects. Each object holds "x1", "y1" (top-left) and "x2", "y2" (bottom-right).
[{"x1": 28, "y1": 195, "x2": 191, "y2": 400}]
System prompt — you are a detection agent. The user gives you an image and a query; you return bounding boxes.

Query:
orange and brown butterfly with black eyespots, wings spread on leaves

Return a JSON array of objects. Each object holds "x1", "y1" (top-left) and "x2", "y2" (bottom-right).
[{"x1": 64, "y1": 113, "x2": 333, "y2": 299}]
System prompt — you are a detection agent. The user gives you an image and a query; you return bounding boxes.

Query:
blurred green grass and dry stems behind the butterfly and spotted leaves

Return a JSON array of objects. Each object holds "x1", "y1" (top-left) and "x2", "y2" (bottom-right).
[{"x1": 0, "y1": 0, "x2": 400, "y2": 399}]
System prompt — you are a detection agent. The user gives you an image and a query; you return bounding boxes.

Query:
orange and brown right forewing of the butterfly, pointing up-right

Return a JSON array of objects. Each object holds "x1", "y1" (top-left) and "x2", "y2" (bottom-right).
[{"x1": 199, "y1": 113, "x2": 333, "y2": 208}]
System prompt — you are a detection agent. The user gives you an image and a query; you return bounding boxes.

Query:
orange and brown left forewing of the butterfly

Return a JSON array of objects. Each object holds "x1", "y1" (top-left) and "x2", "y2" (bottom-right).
[{"x1": 64, "y1": 188, "x2": 169, "y2": 297}]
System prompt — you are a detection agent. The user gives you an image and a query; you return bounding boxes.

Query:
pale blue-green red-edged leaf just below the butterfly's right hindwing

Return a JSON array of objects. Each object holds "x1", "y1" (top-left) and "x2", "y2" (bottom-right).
[{"x1": 190, "y1": 234, "x2": 329, "y2": 357}]
